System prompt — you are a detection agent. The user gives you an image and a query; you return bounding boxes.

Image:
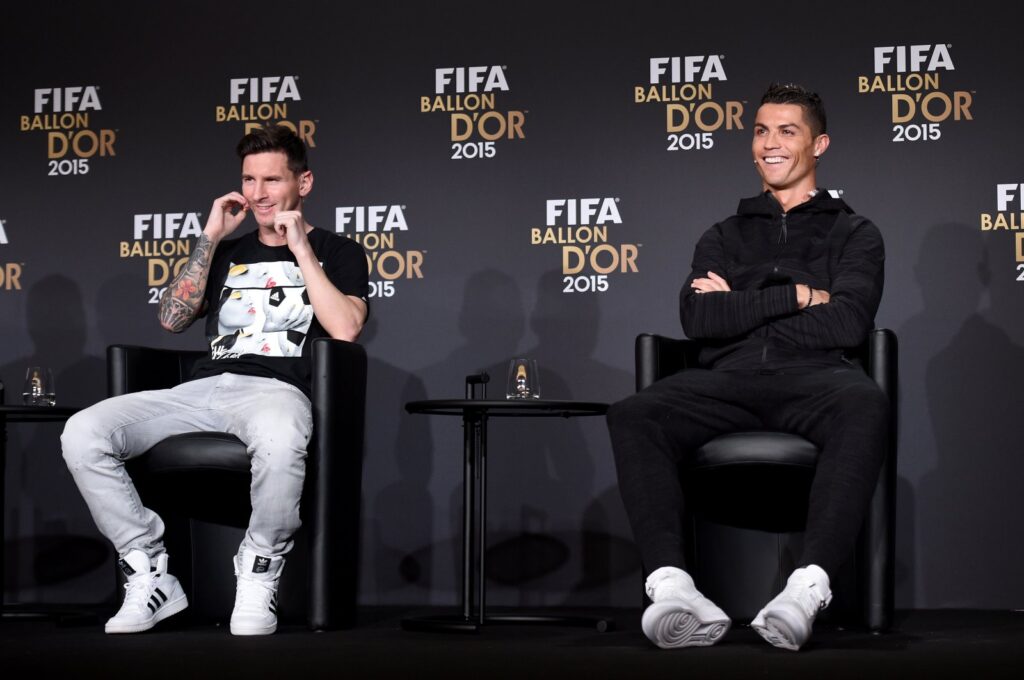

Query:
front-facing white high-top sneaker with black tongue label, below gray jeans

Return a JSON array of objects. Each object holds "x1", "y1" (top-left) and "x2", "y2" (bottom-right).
[{"x1": 231, "y1": 550, "x2": 285, "y2": 635}]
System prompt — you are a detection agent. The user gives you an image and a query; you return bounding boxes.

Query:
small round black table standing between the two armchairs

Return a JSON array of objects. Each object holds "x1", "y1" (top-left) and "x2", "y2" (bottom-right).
[{"x1": 401, "y1": 395, "x2": 611, "y2": 632}]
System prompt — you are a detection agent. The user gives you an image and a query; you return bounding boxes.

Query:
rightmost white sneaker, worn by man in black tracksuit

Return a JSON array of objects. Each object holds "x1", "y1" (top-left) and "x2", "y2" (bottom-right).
[{"x1": 751, "y1": 564, "x2": 831, "y2": 651}]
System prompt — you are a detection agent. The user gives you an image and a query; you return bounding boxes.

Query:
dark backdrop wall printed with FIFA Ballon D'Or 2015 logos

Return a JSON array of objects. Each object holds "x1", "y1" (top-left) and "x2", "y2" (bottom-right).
[{"x1": 0, "y1": 0, "x2": 1024, "y2": 608}]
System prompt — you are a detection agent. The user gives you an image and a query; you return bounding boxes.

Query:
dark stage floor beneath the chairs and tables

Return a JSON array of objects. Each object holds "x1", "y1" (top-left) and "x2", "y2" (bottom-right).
[{"x1": 0, "y1": 609, "x2": 1024, "y2": 680}]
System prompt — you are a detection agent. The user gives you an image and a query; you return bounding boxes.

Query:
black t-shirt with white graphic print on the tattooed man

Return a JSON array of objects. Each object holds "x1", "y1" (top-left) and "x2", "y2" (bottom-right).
[{"x1": 191, "y1": 228, "x2": 369, "y2": 396}]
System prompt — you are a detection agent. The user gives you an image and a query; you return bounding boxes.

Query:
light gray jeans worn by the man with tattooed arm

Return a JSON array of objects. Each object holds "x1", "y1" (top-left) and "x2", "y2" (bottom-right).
[{"x1": 60, "y1": 373, "x2": 312, "y2": 557}]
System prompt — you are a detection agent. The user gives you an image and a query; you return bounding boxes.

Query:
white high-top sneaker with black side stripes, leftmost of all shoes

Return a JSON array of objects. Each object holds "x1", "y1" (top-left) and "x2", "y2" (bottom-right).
[{"x1": 103, "y1": 550, "x2": 188, "y2": 633}]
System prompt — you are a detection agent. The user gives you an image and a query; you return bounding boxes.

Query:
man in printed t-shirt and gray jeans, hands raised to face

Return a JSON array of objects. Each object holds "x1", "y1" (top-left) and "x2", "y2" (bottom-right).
[{"x1": 61, "y1": 126, "x2": 368, "y2": 635}]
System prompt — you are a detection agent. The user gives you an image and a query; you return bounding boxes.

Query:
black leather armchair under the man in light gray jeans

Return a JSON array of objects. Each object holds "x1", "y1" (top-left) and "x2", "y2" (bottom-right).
[{"x1": 106, "y1": 338, "x2": 367, "y2": 630}]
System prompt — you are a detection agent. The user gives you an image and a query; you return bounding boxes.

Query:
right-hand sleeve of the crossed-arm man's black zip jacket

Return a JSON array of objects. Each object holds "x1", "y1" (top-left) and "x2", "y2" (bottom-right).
[{"x1": 769, "y1": 217, "x2": 886, "y2": 349}]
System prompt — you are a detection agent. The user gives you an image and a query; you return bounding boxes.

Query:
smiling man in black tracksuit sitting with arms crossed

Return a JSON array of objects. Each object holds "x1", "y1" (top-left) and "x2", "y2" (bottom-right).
[{"x1": 608, "y1": 85, "x2": 889, "y2": 650}]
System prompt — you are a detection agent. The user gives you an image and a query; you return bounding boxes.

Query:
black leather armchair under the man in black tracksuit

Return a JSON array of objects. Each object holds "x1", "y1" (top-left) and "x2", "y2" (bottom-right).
[{"x1": 636, "y1": 330, "x2": 897, "y2": 632}]
